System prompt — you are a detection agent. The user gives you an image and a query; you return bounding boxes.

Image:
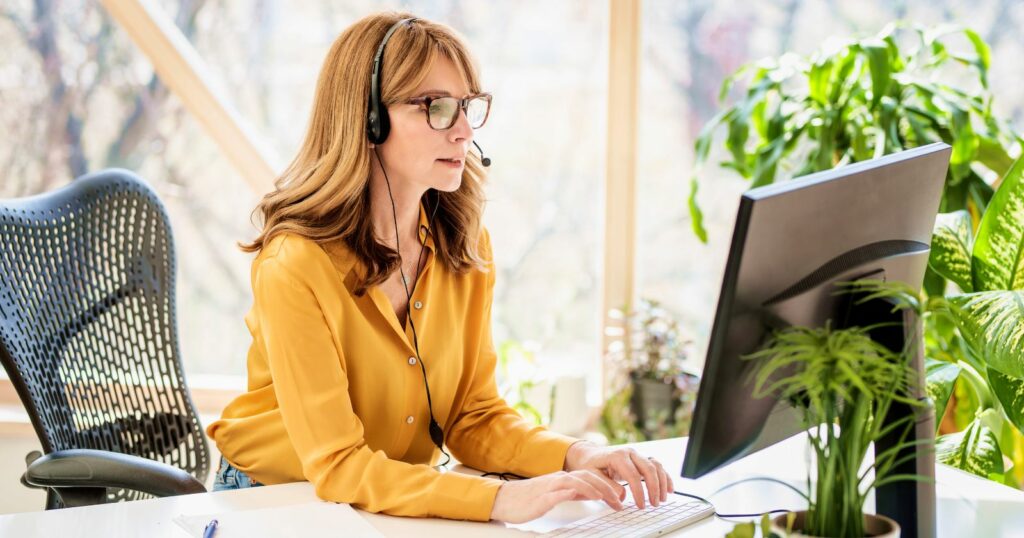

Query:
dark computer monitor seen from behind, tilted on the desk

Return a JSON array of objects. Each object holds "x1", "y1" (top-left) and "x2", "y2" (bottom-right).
[{"x1": 682, "y1": 143, "x2": 950, "y2": 534}]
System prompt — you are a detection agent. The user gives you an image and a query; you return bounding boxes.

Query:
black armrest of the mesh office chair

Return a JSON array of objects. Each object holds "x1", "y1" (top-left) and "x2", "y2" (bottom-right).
[{"x1": 25, "y1": 449, "x2": 206, "y2": 497}]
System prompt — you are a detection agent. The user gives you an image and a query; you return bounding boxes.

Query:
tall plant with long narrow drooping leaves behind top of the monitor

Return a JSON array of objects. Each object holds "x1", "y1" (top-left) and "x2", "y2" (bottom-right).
[{"x1": 689, "y1": 24, "x2": 1021, "y2": 249}]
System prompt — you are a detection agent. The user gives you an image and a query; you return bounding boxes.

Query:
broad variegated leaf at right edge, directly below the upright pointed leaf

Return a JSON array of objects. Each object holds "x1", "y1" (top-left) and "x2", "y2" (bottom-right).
[{"x1": 946, "y1": 291, "x2": 1024, "y2": 378}]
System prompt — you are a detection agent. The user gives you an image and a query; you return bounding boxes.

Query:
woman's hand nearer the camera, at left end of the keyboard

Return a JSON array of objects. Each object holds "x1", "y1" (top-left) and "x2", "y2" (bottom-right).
[{"x1": 490, "y1": 470, "x2": 626, "y2": 523}]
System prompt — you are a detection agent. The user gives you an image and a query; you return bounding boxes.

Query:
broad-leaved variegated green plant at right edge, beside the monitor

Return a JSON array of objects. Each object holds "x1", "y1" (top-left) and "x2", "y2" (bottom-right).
[{"x1": 926, "y1": 153, "x2": 1024, "y2": 487}]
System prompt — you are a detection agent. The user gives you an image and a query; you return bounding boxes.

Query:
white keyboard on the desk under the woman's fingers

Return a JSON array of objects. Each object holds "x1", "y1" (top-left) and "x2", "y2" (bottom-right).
[{"x1": 542, "y1": 495, "x2": 715, "y2": 538}]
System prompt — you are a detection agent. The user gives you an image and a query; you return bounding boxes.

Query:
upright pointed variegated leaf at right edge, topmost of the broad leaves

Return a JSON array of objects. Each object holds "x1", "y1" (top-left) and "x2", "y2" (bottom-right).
[{"x1": 973, "y1": 152, "x2": 1024, "y2": 291}]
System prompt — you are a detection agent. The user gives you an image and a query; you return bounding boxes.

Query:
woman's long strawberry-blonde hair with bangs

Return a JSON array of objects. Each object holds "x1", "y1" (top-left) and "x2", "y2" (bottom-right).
[{"x1": 240, "y1": 12, "x2": 485, "y2": 295}]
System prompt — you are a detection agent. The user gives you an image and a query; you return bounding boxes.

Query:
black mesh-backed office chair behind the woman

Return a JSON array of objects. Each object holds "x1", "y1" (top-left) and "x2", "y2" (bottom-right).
[{"x1": 0, "y1": 169, "x2": 210, "y2": 509}]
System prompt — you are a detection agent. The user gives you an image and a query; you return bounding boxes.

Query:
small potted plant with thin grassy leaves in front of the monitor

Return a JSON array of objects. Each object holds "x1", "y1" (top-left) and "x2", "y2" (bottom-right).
[{"x1": 745, "y1": 281, "x2": 921, "y2": 538}]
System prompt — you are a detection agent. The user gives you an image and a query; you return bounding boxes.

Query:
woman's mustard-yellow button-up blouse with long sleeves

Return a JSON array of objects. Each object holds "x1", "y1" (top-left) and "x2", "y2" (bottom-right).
[{"x1": 207, "y1": 202, "x2": 575, "y2": 521}]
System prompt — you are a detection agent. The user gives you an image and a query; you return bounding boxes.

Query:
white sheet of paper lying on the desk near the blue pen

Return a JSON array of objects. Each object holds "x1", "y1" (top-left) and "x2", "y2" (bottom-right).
[{"x1": 174, "y1": 501, "x2": 383, "y2": 538}]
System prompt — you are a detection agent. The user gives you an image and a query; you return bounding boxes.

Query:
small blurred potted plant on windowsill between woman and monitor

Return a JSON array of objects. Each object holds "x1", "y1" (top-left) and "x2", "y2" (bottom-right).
[{"x1": 600, "y1": 299, "x2": 697, "y2": 444}]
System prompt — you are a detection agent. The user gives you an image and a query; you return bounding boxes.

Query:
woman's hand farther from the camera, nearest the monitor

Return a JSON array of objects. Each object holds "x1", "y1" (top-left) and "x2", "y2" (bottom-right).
[{"x1": 564, "y1": 441, "x2": 674, "y2": 508}]
